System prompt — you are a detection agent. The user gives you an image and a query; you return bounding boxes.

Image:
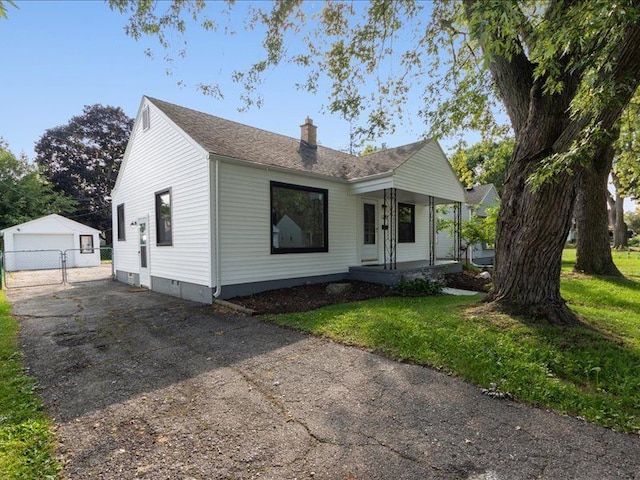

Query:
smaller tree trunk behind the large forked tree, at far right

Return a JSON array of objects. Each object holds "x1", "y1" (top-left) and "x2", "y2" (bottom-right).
[{"x1": 574, "y1": 135, "x2": 622, "y2": 276}]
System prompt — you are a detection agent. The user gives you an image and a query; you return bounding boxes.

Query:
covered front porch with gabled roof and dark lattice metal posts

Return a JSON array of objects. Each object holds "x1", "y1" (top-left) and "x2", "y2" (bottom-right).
[{"x1": 349, "y1": 140, "x2": 465, "y2": 283}]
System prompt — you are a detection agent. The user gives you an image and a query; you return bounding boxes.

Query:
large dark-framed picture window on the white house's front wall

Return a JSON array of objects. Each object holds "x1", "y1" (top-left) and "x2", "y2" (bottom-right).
[{"x1": 271, "y1": 182, "x2": 329, "y2": 253}]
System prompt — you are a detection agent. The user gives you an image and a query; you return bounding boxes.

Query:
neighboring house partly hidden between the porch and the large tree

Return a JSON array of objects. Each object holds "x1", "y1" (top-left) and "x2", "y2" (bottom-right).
[{"x1": 436, "y1": 183, "x2": 500, "y2": 265}]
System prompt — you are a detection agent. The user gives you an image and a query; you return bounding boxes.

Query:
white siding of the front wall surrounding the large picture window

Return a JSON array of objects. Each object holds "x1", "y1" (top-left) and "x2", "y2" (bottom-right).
[{"x1": 215, "y1": 162, "x2": 358, "y2": 285}]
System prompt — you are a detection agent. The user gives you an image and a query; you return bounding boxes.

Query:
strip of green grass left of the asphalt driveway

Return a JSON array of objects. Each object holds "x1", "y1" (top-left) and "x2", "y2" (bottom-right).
[{"x1": 0, "y1": 291, "x2": 60, "y2": 480}]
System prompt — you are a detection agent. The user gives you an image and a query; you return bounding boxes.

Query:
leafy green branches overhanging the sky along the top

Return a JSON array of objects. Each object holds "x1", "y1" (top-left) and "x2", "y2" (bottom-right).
[{"x1": 109, "y1": 0, "x2": 638, "y2": 148}]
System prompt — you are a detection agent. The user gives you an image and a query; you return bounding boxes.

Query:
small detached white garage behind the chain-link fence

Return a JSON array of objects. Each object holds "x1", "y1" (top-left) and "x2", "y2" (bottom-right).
[{"x1": 0, "y1": 214, "x2": 100, "y2": 272}]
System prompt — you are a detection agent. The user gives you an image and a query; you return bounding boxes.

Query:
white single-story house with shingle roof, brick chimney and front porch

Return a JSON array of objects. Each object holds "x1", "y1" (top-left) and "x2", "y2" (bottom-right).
[{"x1": 112, "y1": 97, "x2": 464, "y2": 303}]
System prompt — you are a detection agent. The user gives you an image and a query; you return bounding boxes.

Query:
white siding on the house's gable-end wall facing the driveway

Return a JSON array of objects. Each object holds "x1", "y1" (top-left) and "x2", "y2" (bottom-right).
[{"x1": 113, "y1": 100, "x2": 211, "y2": 286}]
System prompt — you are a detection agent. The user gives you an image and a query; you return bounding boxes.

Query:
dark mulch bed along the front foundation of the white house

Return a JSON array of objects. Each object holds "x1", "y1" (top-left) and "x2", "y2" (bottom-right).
[{"x1": 230, "y1": 271, "x2": 491, "y2": 314}]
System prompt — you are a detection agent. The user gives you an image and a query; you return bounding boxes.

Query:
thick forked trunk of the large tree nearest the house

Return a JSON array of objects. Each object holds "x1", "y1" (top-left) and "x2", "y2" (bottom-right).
[{"x1": 465, "y1": 0, "x2": 640, "y2": 324}]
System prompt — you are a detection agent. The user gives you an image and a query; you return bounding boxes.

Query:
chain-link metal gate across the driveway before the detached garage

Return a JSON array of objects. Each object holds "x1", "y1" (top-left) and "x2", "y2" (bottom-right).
[{"x1": 0, "y1": 247, "x2": 113, "y2": 288}]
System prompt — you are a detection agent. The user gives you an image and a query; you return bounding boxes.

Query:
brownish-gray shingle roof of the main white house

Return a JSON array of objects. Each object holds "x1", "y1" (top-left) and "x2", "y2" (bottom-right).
[{"x1": 146, "y1": 97, "x2": 428, "y2": 180}]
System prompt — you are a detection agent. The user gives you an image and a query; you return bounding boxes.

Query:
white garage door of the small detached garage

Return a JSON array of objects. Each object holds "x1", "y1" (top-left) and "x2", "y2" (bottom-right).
[{"x1": 7, "y1": 233, "x2": 74, "y2": 270}]
